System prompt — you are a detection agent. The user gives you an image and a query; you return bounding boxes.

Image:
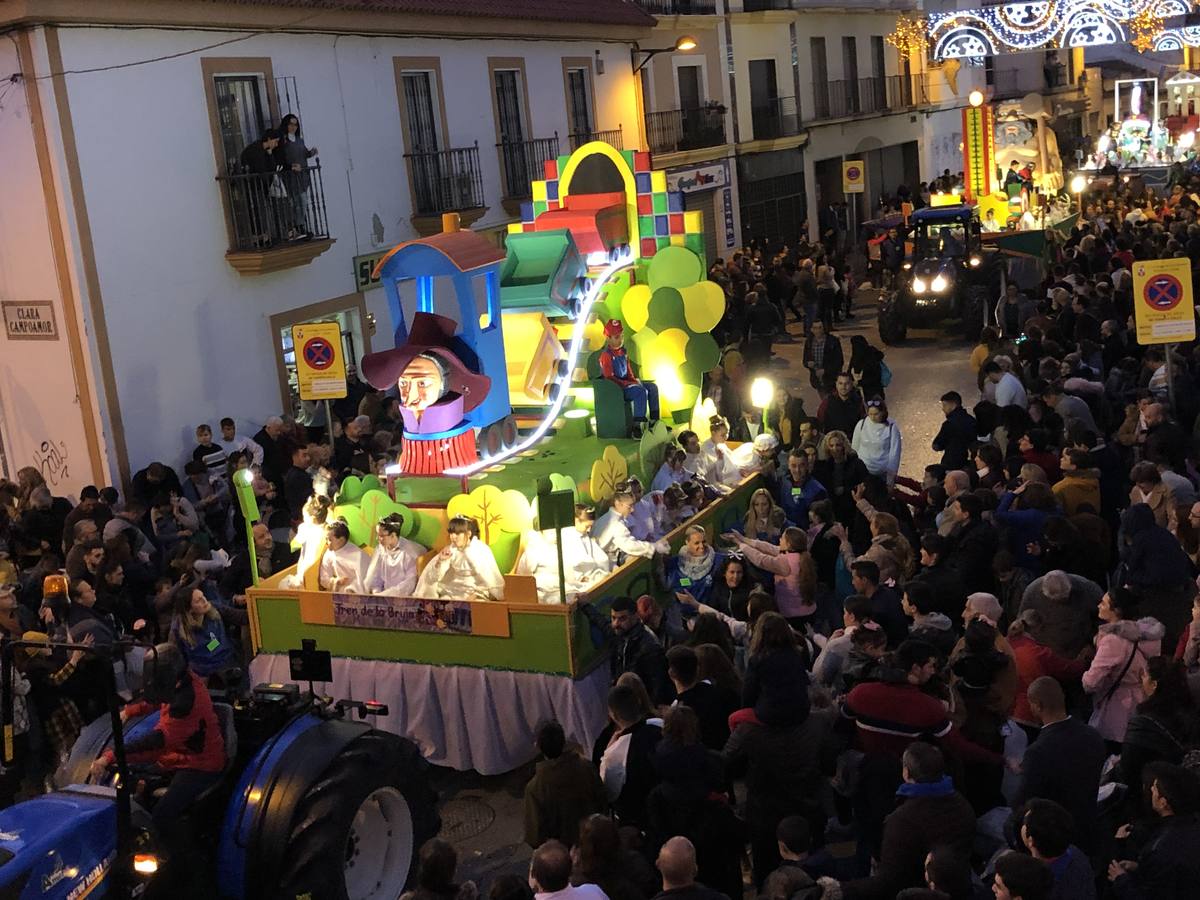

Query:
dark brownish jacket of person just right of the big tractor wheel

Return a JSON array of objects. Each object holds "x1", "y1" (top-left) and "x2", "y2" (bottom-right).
[{"x1": 524, "y1": 751, "x2": 608, "y2": 847}]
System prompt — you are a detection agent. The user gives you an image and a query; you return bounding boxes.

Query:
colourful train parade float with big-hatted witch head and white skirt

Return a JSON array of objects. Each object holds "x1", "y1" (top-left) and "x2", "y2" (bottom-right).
[{"x1": 247, "y1": 142, "x2": 758, "y2": 773}]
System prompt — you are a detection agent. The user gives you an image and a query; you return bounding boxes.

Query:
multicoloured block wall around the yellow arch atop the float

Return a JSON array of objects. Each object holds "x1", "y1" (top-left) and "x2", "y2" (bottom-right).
[{"x1": 509, "y1": 150, "x2": 704, "y2": 259}]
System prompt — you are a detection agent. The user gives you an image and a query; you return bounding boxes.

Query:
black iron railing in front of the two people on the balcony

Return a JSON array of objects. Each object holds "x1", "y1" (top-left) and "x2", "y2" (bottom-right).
[{"x1": 217, "y1": 163, "x2": 329, "y2": 251}]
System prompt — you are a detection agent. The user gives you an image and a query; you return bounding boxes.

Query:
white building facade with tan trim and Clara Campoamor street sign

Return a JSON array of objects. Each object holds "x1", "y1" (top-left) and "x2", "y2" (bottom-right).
[{"x1": 0, "y1": 0, "x2": 654, "y2": 494}]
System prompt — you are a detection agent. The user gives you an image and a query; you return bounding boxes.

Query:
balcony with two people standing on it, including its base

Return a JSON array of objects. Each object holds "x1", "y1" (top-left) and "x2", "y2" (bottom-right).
[{"x1": 217, "y1": 162, "x2": 334, "y2": 275}]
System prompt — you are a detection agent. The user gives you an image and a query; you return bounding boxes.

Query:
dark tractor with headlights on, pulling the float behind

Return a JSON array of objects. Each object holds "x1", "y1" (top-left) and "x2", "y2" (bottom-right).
[{"x1": 878, "y1": 204, "x2": 998, "y2": 344}]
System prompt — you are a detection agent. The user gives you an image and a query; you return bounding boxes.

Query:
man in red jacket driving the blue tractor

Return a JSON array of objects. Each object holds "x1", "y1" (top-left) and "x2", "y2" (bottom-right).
[{"x1": 91, "y1": 643, "x2": 226, "y2": 840}]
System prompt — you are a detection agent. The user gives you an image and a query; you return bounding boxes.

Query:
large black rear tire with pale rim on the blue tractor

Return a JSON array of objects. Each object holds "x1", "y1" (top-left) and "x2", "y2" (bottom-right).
[{"x1": 272, "y1": 731, "x2": 442, "y2": 900}]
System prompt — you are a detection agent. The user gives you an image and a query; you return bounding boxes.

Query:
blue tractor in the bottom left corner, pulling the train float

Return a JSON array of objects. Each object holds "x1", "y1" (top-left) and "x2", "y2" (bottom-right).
[{"x1": 0, "y1": 641, "x2": 440, "y2": 900}]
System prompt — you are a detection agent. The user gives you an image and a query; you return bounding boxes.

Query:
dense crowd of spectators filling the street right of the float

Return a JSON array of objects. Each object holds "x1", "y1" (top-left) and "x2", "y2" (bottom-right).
[{"x1": 499, "y1": 192, "x2": 1200, "y2": 900}]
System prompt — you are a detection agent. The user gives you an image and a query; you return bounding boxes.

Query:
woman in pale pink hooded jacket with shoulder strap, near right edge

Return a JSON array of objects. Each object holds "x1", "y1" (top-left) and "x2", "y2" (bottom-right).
[{"x1": 1084, "y1": 588, "x2": 1163, "y2": 749}]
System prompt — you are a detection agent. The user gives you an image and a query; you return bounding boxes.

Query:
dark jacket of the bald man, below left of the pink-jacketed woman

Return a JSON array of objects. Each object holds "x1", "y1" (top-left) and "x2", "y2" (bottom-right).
[{"x1": 1013, "y1": 716, "x2": 1108, "y2": 851}]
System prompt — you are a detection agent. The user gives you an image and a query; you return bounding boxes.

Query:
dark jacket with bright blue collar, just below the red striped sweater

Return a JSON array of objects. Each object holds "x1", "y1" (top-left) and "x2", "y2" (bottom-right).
[{"x1": 842, "y1": 776, "x2": 976, "y2": 900}]
